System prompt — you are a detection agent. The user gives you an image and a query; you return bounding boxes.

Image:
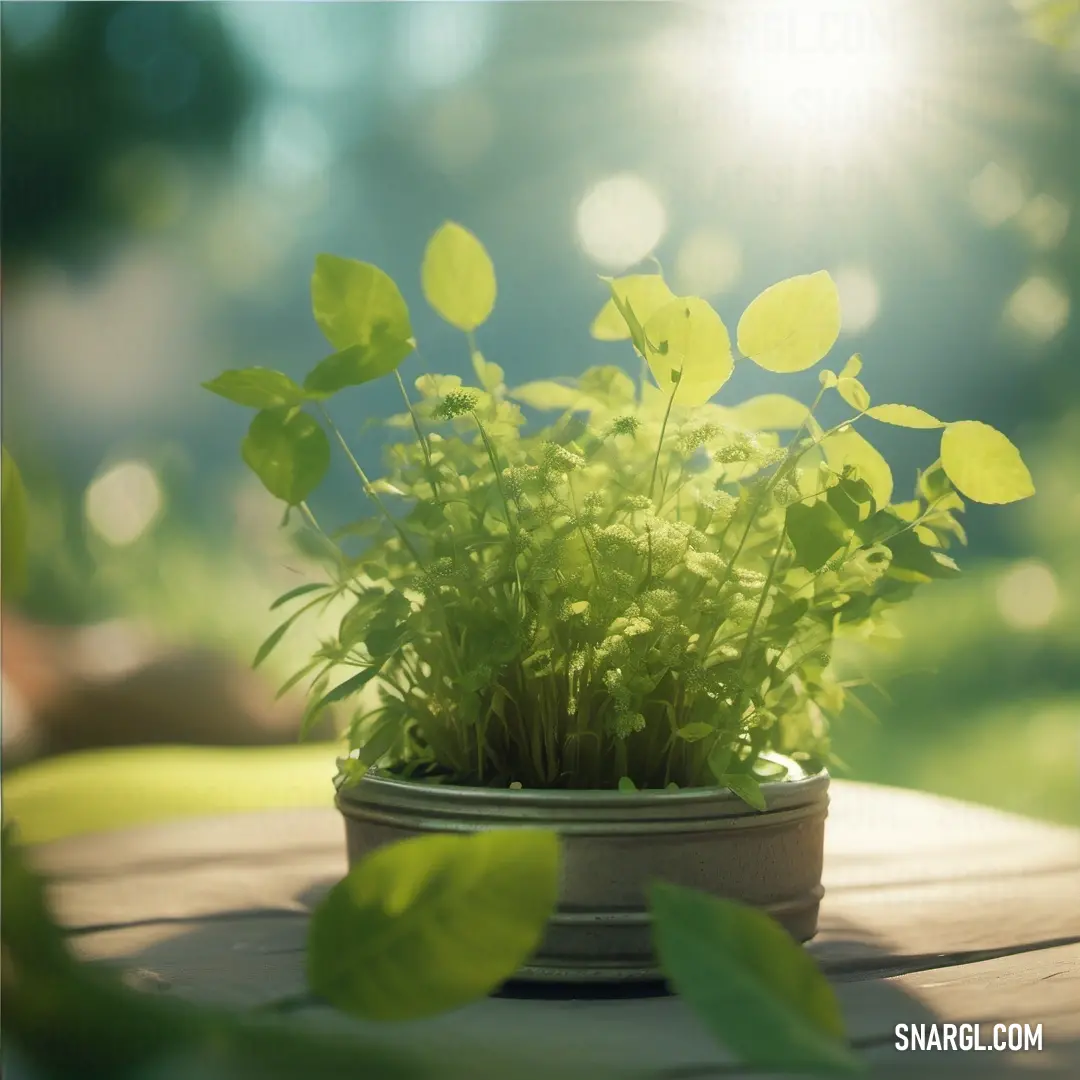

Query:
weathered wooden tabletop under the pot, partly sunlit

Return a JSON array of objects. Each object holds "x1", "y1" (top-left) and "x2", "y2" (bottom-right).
[{"x1": 35, "y1": 782, "x2": 1080, "y2": 1080}]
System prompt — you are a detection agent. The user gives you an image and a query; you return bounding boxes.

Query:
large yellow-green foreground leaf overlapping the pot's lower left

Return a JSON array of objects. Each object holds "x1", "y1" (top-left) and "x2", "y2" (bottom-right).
[{"x1": 308, "y1": 828, "x2": 559, "y2": 1021}]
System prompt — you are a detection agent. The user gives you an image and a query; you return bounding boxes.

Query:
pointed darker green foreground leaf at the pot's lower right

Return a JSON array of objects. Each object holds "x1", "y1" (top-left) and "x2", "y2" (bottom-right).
[{"x1": 649, "y1": 882, "x2": 863, "y2": 1072}]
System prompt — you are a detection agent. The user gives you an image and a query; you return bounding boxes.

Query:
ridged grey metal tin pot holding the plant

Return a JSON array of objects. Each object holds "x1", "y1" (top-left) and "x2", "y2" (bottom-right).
[{"x1": 337, "y1": 770, "x2": 828, "y2": 983}]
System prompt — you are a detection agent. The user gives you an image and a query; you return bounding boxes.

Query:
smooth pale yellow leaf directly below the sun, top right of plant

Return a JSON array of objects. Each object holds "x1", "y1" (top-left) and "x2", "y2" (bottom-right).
[{"x1": 739, "y1": 270, "x2": 840, "y2": 372}]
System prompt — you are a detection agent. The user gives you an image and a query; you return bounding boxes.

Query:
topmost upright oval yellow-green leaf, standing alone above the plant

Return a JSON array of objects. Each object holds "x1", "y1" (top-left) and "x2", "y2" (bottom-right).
[{"x1": 420, "y1": 221, "x2": 496, "y2": 332}]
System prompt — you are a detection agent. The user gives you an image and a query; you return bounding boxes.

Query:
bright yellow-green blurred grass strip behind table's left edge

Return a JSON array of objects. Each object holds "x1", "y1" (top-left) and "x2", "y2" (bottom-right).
[{"x1": 3, "y1": 743, "x2": 339, "y2": 843}]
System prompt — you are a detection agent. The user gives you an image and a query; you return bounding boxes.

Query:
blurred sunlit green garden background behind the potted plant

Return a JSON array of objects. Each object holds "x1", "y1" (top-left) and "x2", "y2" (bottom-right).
[{"x1": 0, "y1": 0, "x2": 1080, "y2": 838}]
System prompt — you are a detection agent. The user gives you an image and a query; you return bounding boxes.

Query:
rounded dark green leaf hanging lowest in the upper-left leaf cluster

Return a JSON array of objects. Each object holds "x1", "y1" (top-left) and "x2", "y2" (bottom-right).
[{"x1": 241, "y1": 408, "x2": 330, "y2": 507}]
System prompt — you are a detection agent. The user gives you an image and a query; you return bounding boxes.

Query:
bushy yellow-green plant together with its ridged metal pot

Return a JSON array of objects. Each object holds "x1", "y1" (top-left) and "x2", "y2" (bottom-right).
[{"x1": 206, "y1": 224, "x2": 1034, "y2": 980}]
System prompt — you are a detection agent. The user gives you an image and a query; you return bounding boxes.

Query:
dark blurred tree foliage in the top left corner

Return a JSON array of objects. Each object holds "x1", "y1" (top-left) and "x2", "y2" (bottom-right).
[{"x1": 0, "y1": 2, "x2": 254, "y2": 273}]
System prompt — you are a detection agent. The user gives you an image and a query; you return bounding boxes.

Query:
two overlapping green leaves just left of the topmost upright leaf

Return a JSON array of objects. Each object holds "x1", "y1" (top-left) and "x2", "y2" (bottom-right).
[{"x1": 313, "y1": 255, "x2": 415, "y2": 384}]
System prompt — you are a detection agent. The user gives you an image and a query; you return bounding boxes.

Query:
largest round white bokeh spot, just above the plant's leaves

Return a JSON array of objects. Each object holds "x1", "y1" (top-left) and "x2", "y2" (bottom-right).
[{"x1": 577, "y1": 173, "x2": 667, "y2": 270}]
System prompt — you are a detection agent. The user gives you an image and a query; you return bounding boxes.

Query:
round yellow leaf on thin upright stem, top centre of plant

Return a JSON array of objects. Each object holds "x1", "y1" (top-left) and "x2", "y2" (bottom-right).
[{"x1": 645, "y1": 296, "x2": 734, "y2": 405}]
